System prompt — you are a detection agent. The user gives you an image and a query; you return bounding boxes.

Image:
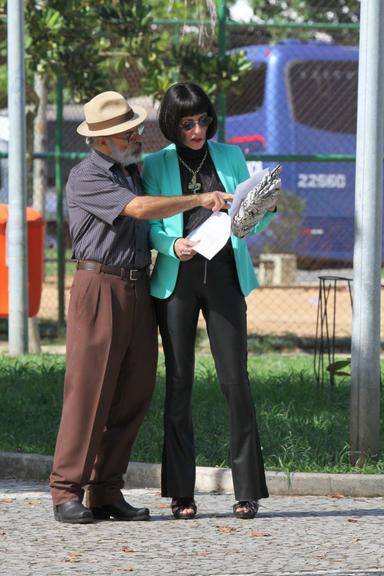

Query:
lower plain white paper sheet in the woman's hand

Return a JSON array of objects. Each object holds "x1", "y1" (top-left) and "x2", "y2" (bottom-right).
[{"x1": 187, "y1": 212, "x2": 231, "y2": 260}]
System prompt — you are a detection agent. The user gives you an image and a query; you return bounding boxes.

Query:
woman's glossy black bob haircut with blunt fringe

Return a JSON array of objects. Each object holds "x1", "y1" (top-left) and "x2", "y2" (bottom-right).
[{"x1": 159, "y1": 82, "x2": 217, "y2": 144}]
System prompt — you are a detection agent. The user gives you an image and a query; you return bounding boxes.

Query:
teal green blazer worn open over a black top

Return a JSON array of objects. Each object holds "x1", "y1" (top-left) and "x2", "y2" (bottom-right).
[{"x1": 143, "y1": 141, "x2": 274, "y2": 298}]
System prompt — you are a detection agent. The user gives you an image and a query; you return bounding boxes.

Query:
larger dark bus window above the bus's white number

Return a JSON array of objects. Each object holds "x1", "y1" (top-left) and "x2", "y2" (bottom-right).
[{"x1": 286, "y1": 60, "x2": 358, "y2": 134}]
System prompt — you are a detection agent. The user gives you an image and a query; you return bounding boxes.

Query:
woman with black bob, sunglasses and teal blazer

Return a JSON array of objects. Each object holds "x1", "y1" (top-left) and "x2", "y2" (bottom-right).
[{"x1": 143, "y1": 82, "x2": 273, "y2": 519}]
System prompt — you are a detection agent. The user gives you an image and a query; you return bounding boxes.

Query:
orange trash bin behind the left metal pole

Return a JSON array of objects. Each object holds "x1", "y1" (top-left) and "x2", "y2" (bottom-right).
[{"x1": 0, "y1": 204, "x2": 44, "y2": 318}]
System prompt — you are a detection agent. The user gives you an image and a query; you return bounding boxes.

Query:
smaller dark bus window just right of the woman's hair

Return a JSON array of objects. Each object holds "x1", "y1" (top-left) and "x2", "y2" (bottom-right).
[{"x1": 227, "y1": 63, "x2": 267, "y2": 116}]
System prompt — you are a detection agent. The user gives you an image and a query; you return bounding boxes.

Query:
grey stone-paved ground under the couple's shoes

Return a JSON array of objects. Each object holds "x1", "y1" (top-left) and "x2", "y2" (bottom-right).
[{"x1": 0, "y1": 480, "x2": 384, "y2": 576}]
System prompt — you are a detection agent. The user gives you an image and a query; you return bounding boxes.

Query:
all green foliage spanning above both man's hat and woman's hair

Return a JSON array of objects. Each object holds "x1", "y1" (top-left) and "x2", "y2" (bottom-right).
[{"x1": 0, "y1": 0, "x2": 252, "y2": 105}]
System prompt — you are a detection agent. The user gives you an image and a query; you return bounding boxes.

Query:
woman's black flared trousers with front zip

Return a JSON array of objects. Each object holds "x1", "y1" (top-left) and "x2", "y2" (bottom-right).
[{"x1": 156, "y1": 257, "x2": 268, "y2": 500}]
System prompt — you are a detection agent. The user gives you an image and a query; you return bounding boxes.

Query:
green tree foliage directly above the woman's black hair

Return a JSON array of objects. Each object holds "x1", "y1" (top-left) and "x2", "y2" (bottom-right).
[{"x1": 118, "y1": 0, "x2": 251, "y2": 100}]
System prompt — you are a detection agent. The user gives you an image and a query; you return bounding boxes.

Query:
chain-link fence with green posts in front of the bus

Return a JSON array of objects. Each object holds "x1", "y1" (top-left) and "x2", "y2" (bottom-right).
[{"x1": 0, "y1": 2, "x2": 380, "y2": 344}]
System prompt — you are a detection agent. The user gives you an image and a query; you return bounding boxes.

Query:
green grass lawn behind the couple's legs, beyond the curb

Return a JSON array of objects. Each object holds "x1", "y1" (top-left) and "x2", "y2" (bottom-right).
[{"x1": 0, "y1": 354, "x2": 384, "y2": 473}]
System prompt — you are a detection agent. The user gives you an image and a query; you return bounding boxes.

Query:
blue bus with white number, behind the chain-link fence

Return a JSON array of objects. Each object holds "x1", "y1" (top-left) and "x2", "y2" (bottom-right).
[{"x1": 226, "y1": 40, "x2": 358, "y2": 262}]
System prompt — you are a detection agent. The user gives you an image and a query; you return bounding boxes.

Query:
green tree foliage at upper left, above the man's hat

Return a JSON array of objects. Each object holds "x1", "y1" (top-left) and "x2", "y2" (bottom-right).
[{"x1": 0, "y1": 0, "x2": 154, "y2": 99}]
